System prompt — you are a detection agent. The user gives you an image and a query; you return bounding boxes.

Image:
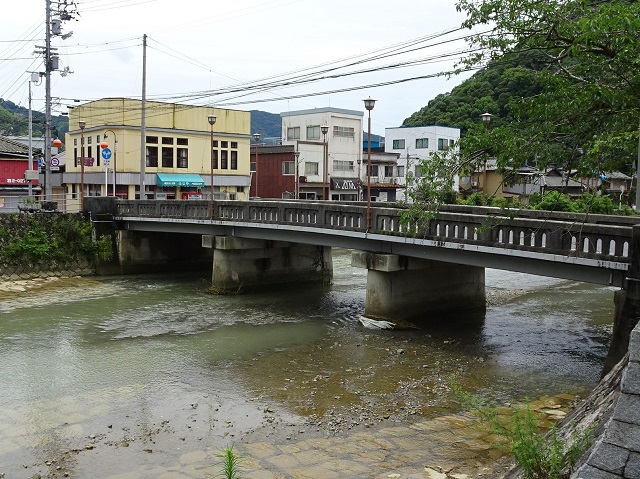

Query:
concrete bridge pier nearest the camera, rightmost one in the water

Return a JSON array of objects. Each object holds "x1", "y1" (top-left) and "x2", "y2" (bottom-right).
[{"x1": 351, "y1": 251, "x2": 486, "y2": 322}]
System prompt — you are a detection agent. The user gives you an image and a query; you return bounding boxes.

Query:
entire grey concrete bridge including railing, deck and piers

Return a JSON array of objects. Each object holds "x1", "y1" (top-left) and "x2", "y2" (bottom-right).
[{"x1": 85, "y1": 197, "x2": 640, "y2": 372}]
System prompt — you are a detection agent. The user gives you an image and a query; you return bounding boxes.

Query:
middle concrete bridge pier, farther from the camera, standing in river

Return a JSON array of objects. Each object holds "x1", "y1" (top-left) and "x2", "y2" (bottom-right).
[{"x1": 202, "y1": 235, "x2": 333, "y2": 294}]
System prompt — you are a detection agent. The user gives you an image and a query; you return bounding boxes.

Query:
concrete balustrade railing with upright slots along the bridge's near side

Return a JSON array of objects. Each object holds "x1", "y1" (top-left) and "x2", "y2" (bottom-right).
[{"x1": 104, "y1": 200, "x2": 640, "y2": 263}]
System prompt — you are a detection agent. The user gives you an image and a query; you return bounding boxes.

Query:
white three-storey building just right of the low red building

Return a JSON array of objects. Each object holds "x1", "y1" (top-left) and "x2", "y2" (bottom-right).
[{"x1": 280, "y1": 107, "x2": 364, "y2": 201}]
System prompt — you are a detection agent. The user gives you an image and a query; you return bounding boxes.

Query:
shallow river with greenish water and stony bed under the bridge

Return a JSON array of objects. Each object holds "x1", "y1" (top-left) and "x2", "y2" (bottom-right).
[{"x1": 0, "y1": 250, "x2": 614, "y2": 479}]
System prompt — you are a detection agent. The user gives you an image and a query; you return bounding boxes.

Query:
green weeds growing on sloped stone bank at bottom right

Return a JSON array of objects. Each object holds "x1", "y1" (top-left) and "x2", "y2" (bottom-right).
[{"x1": 451, "y1": 377, "x2": 591, "y2": 479}]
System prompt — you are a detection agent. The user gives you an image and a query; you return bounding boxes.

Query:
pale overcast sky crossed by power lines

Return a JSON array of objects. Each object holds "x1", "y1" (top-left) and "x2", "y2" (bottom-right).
[{"x1": 0, "y1": 0, "x2": 478, "y2": 134}]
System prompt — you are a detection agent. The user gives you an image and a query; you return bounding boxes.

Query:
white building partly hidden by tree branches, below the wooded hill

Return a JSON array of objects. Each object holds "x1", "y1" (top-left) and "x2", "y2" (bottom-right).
[{"x1": 385, "y1": 125, "x2": 460, "y2": 200}]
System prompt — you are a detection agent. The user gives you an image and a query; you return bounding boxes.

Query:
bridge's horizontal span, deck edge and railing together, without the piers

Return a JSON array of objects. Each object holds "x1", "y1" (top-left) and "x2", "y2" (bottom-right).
[{"x1": 89, "y1": 198, "x2": 640, "y2": 286}]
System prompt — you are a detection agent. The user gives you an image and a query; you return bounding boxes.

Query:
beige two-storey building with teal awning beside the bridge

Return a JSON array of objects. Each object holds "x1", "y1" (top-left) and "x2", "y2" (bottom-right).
[{"x1": 62, "y1": 98, "x2": 251, "y2": 200}]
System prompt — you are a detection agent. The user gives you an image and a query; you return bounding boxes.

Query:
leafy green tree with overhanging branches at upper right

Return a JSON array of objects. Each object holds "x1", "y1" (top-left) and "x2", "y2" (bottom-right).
[{"x1": 457, "y1": 0, "x2": 640, "y2": 175}]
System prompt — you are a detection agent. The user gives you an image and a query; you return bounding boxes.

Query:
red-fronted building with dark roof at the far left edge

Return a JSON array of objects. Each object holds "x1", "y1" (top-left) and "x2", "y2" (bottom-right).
[{"x1": 0, "y1": 136, "x2": 40, "y2": 211}]
